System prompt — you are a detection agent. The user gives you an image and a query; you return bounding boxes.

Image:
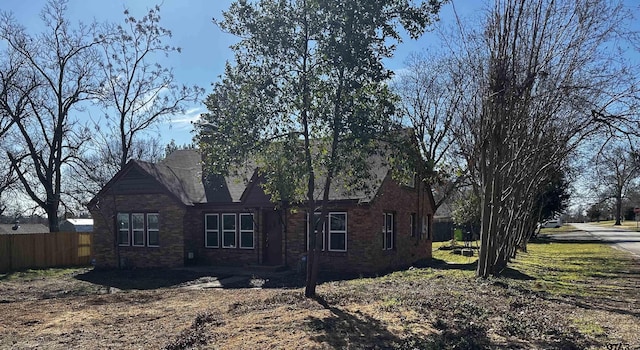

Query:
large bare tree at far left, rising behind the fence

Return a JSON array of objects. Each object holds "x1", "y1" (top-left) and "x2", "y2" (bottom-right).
[{"x1": 0, "y1": 0, "x2": 99, "y2": 232}]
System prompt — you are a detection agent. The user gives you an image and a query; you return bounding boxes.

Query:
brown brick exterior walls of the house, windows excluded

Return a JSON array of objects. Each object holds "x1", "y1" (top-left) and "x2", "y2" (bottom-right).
[{"x1": 91, "y1": 172, "x2": 433, "y2": 273}]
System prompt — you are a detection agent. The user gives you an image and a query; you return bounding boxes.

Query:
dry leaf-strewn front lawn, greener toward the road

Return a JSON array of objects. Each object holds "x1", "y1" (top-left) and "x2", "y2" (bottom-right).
[{"x1": 0, "y1": 239, "x2": 640, "y2": 349}]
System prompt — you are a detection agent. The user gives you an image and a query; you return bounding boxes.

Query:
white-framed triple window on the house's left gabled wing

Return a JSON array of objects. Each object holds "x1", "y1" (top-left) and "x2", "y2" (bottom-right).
[{"x1": 117, "y1": 213, "x2": 160, "y2": 247}]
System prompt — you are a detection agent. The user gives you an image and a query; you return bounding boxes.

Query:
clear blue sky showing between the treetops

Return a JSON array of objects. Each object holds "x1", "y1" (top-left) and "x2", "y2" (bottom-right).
[{"x1": 0, "y1": 0, "x2": 639, "y2": 148}]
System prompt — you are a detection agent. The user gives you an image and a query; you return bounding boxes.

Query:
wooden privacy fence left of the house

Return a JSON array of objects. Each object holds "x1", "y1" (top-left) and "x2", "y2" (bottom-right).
[{"x1": 0, "y1": 232, "x2": 91, "y2": 272}]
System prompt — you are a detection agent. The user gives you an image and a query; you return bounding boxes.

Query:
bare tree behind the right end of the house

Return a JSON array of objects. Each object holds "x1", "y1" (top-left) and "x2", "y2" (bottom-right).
[{"x1": 392, "y1": 54, "x2": 468, "y2": 210}]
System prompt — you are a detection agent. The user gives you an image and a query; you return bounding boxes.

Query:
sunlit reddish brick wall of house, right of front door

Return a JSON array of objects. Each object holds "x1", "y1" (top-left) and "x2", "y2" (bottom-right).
[{"x1": 287, "y1": 179, "x2": 433, "y2": 273}]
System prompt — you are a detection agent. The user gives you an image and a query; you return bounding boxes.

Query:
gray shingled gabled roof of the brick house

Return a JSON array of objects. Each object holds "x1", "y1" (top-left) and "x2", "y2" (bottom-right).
[{"x1": 90, "y1": 145, "x2": 424, "y2": 206}]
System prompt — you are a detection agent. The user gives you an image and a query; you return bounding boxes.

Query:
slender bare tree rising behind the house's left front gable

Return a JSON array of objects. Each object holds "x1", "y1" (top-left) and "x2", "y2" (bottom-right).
[{"x1": 93, "y1": 6, "x2": 203, "y2": 176}]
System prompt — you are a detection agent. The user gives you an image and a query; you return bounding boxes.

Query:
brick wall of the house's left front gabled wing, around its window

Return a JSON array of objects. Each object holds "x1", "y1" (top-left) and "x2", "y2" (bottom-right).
[{"x1": 91, "y1": 194, "x2": 186, "y2": 268}]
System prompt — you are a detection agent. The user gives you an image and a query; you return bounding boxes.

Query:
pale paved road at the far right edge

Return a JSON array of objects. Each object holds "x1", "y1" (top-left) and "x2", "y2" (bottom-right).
[{"x1": 567, "y1": 223, "x2": 640, "y2": 257}]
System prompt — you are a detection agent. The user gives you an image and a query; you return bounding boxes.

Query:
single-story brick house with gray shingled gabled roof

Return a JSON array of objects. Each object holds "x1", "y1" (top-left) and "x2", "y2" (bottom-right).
[{"x1": 89, "y1": 150, "x2": 434, "y2": 273}]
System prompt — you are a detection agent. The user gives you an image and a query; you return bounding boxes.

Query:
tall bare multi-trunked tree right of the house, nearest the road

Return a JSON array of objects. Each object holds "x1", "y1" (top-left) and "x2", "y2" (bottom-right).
[{"x1": 450, "y1": 0, "x2": 636, "y2": 277}]
